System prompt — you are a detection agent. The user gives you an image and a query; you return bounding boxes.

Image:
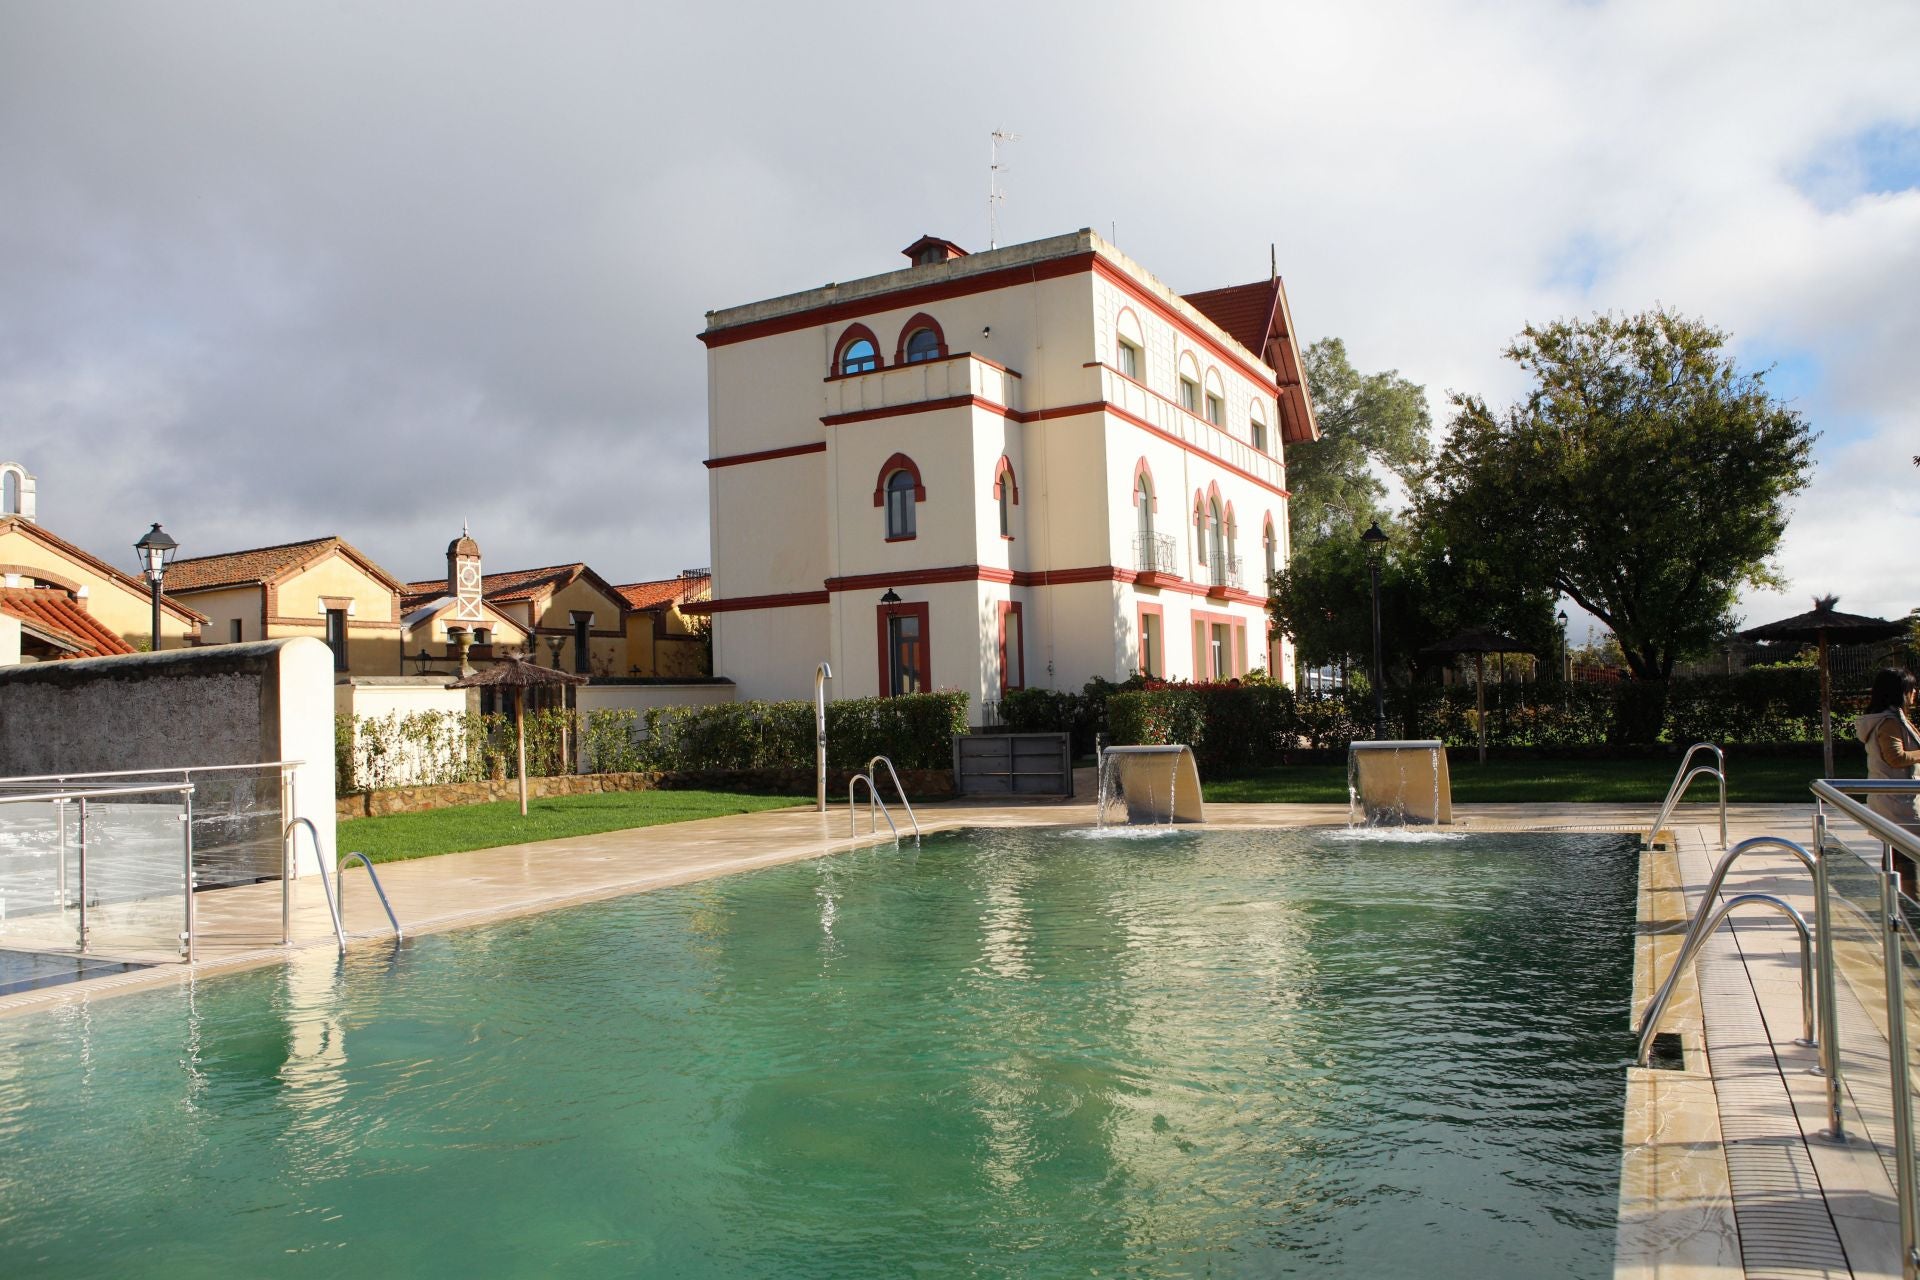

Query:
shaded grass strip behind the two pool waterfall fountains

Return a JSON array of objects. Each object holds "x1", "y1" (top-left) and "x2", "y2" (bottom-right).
[{"x1": 1200, "y1": 743, "x2": 1866, "y2": 810}]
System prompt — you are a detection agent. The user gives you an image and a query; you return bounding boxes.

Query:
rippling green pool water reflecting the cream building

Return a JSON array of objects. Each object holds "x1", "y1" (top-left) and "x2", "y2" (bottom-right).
[{"x1": 0, "y1": 831, "x2": 1636, "y2": 1278}]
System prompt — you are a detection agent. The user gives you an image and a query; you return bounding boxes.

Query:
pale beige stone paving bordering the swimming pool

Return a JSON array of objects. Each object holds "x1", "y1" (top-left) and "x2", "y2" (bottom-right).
[{"x1": 0, "y1": 802, "x2": 1901, "y2": 1280}]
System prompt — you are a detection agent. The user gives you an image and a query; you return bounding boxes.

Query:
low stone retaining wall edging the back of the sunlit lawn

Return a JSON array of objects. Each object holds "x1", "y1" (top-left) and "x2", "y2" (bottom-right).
[{"x1": 336, "y1": 770, "x2": 954, "y2": 821}]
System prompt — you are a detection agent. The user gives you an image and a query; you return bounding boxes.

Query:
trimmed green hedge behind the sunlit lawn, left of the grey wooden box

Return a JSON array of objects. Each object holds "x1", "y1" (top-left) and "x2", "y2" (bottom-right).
[{"x1": 637, "y1": 691, "x2": 968, "y2": 770}]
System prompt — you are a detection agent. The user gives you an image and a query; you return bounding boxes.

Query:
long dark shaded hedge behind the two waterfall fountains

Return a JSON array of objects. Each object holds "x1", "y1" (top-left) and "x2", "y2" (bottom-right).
[{"x1": 1106, "y1": 668, "x2": 1860, "y2": 771}]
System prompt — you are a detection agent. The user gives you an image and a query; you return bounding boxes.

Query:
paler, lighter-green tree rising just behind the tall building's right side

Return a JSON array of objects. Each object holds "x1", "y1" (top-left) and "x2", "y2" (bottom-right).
[{"x1": 1286, "y1": 338, "x2": 1432, "y2": 547}]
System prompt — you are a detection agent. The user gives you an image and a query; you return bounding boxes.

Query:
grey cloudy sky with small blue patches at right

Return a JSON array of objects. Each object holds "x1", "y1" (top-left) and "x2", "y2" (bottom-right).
[{"x1": 0, "y1": 0, "x2": 1920, "y2": 622}]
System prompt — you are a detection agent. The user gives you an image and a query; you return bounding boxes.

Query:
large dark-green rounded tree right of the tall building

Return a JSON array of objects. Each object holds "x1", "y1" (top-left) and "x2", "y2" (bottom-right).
[{"x1": 1419, "y1": 311, "x2": 1814, "y2": 679}]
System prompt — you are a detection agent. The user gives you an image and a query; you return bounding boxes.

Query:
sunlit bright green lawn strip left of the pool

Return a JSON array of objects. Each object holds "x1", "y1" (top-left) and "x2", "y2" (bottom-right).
[{"x1": 334, "y1": 791, "x2": 812, "y2": 862}]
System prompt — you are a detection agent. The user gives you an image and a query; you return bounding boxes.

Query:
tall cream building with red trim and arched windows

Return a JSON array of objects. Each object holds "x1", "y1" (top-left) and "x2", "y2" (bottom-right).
[{"x1": 701, "y1": 230, "x2": 1315, "y2": 716}]
